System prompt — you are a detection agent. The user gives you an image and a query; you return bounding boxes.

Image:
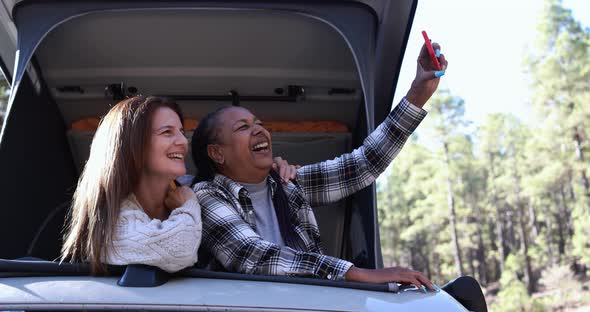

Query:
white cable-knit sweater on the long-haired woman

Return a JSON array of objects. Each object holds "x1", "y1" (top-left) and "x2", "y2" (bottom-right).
[{"x1": 105, "y1": 194, "x2": 202, "y2": 272}]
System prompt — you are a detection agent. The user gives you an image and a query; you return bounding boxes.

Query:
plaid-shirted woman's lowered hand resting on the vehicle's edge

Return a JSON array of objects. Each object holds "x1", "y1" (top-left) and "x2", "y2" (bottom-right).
[{"x1": 344, "y1": 266, "x2": 436, "y2": 291}]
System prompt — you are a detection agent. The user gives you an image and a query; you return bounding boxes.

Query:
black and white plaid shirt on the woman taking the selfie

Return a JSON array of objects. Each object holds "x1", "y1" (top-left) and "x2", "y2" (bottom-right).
[{"x1": 193, "y1": 98, "x2": 426, "y2": 280}]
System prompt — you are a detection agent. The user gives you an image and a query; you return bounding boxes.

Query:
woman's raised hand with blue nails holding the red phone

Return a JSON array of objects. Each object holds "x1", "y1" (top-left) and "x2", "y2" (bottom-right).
[{"x1": 406, "y1": 43, "x2": 449, "y2": 108}]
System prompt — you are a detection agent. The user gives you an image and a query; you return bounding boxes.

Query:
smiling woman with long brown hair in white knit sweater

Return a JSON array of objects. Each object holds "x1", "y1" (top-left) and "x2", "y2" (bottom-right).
[{"x1": 62, "y1": 96, "x2": 201, "y2": 274}]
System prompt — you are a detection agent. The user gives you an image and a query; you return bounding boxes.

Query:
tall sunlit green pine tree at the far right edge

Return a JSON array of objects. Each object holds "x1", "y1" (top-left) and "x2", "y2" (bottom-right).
[{"x1": 527, "y1": 0, "x2": 590, "y2": 265}]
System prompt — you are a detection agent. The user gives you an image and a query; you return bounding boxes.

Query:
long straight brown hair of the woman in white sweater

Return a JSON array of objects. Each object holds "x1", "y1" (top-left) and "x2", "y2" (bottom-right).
[{"x1": 61, "y1": 96, "x2": 183, "y2": 274}]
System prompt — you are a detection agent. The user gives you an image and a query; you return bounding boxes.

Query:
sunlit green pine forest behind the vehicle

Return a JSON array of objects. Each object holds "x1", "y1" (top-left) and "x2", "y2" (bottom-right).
[{"x1": 378, "y1": 0, "x2": 590, "y2": 311}]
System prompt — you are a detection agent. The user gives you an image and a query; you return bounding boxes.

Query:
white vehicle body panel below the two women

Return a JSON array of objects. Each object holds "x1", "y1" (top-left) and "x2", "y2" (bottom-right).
[{"x1": 0, "y1": 276, "x2": 470, "y2": 311}]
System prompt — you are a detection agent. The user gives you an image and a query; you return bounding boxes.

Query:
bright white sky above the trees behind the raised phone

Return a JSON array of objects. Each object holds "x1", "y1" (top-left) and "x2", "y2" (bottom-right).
[{"x1": 394, "y1": 0, "x2": 590, "y2": 125}]
